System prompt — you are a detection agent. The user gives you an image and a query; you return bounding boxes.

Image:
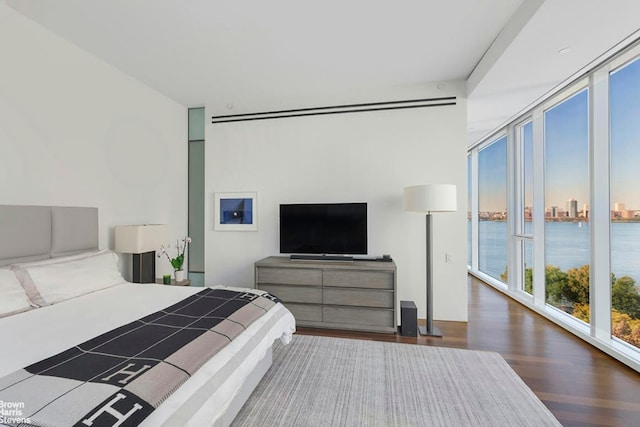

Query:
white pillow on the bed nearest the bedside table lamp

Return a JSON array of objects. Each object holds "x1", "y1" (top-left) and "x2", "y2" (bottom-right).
[{"x1": 12, "y1": 251, "x2": 125, "y2": 306}]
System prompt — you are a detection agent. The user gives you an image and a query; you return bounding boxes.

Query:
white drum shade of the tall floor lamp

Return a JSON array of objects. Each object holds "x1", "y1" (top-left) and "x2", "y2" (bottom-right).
[{"x1": 404, "y1": 184, "x2": 456, "y2": 212}]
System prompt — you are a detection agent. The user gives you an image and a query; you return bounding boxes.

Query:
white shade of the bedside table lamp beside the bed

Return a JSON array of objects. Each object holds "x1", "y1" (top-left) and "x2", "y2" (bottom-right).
[{"x1": 115, "y1": 224, "x2": 169, "y2": 254}]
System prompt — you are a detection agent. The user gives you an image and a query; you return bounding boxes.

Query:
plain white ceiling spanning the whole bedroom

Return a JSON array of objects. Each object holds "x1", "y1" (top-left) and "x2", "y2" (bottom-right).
[{"x1": 6, "y1": 0, "x2": 640, "y2": 142}]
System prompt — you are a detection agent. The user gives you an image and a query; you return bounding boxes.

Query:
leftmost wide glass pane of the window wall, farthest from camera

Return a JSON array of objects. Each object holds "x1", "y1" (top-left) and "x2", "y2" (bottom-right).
[{"x1": 478, "y1": 136, "x2": 508, "y2": 283}]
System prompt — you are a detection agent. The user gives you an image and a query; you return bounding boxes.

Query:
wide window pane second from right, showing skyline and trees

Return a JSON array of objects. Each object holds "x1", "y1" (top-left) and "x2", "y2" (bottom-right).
[{"x1": 544, "y1": 89, "x2": 590, "y2": 322}]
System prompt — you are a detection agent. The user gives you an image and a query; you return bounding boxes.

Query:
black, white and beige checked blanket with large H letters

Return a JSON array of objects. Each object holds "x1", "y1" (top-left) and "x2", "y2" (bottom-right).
[{"x1": 0, "y1": 288, "x2": 279, "y2": 427}]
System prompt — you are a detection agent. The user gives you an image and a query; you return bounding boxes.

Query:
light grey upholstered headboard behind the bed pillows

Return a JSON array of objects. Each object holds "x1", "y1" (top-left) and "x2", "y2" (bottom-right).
[{"x1": 0, "y1": 205, "x2": 98, "y2": 266}]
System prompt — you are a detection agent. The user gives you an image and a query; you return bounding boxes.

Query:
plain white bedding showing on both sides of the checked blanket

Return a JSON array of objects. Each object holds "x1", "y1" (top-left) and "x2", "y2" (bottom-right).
[{"x1": 0, "y1": 283, "x2": 295, "y2": 426}]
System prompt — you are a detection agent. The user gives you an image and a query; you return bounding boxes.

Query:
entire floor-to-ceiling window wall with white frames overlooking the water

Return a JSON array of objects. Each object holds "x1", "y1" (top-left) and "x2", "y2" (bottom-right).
[{"x1": 468, "y1": 39, "x2": 640, "y2": 369}]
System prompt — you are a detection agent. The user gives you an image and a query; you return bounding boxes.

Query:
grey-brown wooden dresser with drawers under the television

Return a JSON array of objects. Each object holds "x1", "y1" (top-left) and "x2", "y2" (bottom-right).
[{"x1": 255, "y1": 257, "x2": 397, "y2": 333}]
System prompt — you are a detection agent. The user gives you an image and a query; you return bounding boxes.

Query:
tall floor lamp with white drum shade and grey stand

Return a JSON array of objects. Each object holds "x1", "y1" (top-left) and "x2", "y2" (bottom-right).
[{"x1": 404, "y1": 184, "x2": 456, "y2": 337}]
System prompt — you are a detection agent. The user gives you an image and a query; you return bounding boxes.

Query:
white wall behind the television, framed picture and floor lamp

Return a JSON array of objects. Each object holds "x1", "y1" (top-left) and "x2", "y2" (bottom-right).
[{"x1": 205, "y1": 84, "x2": 467, "y2": 321}]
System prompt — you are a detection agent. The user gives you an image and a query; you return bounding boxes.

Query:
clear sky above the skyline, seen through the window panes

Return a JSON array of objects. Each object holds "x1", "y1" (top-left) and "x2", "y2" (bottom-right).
[{"x1": 478, "y1": 54, "x2": 640, "y2": 211}]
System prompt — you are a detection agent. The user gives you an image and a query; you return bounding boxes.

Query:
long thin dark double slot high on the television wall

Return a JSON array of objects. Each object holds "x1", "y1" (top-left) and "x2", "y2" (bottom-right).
[{"x1": 211, "y1": 96, "x2": 456, "y2": 124}]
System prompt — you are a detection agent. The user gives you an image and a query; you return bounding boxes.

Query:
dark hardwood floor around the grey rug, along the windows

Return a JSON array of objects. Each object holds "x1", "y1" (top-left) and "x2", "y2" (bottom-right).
[{"x1": 298, "y1": 276, "x2": 640, "y2": 426}]
